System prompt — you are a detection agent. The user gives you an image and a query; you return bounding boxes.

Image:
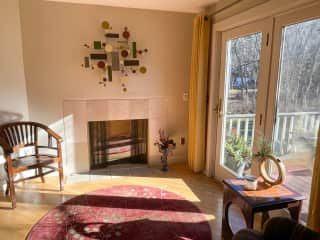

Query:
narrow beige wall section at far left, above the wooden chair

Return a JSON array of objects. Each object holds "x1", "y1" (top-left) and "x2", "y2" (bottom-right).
[{"x1": 0, "y1": 0, "x2": 28, "y2": 191}]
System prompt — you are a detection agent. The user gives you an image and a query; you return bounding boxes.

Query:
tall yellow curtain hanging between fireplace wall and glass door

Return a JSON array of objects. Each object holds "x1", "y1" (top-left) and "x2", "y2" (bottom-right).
[{"x1": 188, "y1": 15, "x2": 211, "y2": 172}]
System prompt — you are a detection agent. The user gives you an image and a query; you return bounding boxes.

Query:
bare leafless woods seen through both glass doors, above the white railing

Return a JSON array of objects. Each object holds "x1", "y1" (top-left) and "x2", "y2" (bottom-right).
[{"x1": 228, "y1": 19, "x2": 320, "y2": 113}]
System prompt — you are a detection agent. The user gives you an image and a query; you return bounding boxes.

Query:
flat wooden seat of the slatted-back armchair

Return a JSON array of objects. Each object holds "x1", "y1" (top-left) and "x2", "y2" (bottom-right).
[{"x1": 12, "y1": 155, "x2": 58, "y2": 169}]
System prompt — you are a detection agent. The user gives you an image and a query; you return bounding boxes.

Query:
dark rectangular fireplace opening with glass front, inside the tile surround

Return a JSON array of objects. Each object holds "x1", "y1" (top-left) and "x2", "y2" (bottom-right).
[{"x1": 88, "y1": 119, "x2": 148, "y2": 169}]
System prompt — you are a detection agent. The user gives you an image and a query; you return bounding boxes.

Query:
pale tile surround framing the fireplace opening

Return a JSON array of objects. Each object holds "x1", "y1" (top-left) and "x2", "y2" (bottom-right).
[{"x1": 63, "y1": 98, "x2": 168, "y2": 174}]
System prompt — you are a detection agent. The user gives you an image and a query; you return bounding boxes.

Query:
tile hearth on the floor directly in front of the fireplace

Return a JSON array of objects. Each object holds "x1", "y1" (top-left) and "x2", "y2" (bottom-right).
[{"x1": 66, "y1": 163, "x2": 161, "y2": 183}]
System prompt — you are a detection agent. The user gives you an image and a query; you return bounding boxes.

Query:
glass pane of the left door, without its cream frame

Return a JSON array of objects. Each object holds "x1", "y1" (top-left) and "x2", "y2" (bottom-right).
[{"x1": 221, "y1": 32, "x2": 262, "y2": 176}]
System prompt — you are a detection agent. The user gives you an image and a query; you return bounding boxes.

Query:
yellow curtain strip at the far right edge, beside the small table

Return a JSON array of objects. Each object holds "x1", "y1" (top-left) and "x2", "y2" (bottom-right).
[{"x1": 308, "y1": 127, "x2": 320, "y2": 232}]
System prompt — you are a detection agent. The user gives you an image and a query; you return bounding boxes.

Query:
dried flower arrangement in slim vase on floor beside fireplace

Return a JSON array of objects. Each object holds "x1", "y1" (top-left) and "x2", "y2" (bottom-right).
[{"x1": 154, "y1": 128, "x2": 176, "y2": 171}]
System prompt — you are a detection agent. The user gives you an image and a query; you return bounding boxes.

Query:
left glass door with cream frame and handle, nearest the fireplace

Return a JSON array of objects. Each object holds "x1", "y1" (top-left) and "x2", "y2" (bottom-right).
[{"x1": 215, "y1": 19, "x2": 272, "y2": 178}]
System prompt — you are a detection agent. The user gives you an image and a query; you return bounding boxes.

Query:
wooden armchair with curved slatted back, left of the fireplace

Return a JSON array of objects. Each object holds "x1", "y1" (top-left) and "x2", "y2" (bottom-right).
[{"x1": 0, "y1": 122, "x2": 63, "y2": 208}]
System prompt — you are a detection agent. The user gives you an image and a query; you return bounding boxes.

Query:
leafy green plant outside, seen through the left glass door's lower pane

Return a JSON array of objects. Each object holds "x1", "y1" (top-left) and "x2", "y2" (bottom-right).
[{"x1": 225, "y1": 135, "x2": 252, "y2": 177}]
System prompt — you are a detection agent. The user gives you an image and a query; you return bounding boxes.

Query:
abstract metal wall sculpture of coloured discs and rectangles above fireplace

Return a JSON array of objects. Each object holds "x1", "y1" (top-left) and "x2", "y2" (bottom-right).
[{"x1": 82, "y1": 21, "x2": 148, "y2": 92}]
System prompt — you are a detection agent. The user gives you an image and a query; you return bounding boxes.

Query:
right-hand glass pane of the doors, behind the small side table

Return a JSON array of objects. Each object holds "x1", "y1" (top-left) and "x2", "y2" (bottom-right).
[{"x1": 273, "y1": 19, "x2": 320, "y2": 220}]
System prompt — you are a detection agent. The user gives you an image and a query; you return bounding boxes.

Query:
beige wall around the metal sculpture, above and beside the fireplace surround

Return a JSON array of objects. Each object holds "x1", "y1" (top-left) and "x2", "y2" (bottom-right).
[{"x1": 20, "y1": 0, "x2": 194, "y2": 168}]
